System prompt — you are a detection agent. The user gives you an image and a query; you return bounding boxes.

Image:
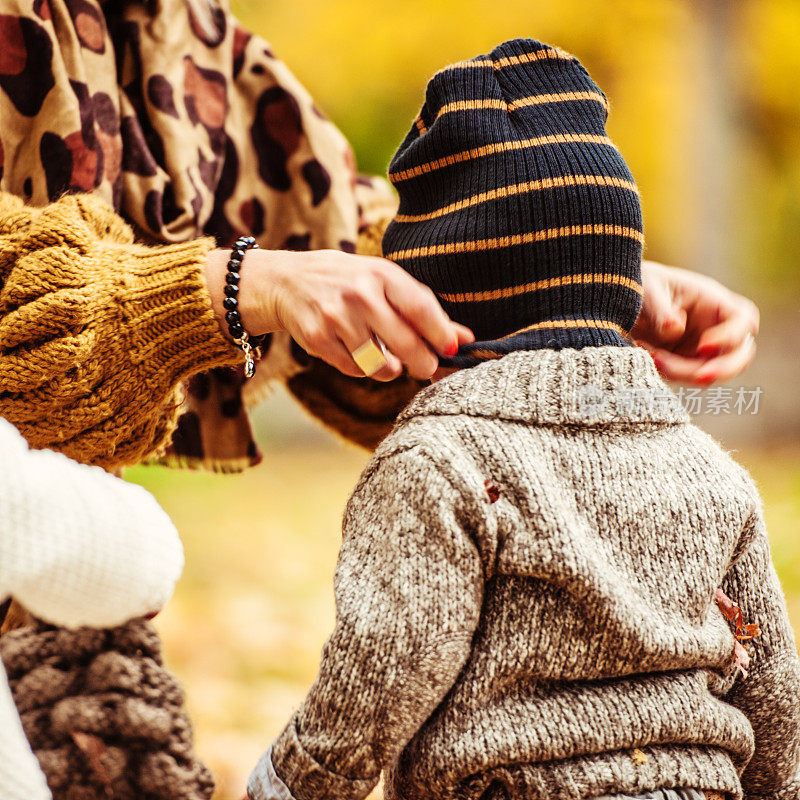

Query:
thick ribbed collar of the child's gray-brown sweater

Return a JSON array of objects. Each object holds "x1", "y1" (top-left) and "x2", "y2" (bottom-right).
[{"x1": 400, "y1": 347, "x2": 689, "y2": 428}]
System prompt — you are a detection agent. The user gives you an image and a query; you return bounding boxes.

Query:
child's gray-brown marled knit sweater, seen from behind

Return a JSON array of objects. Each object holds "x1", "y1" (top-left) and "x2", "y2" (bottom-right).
[{"x1": 249, "y1": 347, "x2": 800, "y2": 800}]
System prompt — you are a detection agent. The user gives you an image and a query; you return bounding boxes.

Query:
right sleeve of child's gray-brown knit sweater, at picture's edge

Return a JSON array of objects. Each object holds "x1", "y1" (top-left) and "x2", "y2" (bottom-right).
[{"x1": 722, "y1": 508, "x2": 800, "y2": 800}]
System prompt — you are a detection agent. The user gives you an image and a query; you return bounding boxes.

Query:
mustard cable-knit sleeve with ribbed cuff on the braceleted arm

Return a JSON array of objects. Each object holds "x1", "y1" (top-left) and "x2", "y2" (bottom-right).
[{"x1": 0, "y1": 193, "x2": 240, "y2": 468}]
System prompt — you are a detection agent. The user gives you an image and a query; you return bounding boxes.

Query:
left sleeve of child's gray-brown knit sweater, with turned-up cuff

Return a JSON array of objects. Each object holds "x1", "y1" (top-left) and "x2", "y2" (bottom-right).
[{"x1": 248, "y1": 450, "x2": 483, "y2": 800}]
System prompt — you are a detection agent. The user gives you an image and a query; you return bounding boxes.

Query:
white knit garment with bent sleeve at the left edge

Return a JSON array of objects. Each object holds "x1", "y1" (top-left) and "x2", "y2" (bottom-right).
[{"x1": 0, "y1": 419, "x2": 183, "y2": 800}]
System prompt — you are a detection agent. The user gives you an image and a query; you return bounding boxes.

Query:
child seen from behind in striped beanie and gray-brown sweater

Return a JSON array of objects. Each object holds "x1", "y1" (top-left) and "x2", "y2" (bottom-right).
[{"x1": 249, "y1": 40, "x2": 800, "y2": 800}]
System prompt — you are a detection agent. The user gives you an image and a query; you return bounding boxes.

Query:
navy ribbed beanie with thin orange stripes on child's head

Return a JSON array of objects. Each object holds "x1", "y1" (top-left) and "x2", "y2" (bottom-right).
[{"x1": 383, "y1": 39, "x2": 644, "y2": 366}]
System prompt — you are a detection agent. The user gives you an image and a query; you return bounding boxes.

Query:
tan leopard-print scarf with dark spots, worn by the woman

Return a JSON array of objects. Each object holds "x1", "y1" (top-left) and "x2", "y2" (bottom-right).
[{"x1": 0, "y1": 0, "x2": 394, "y2": 471}]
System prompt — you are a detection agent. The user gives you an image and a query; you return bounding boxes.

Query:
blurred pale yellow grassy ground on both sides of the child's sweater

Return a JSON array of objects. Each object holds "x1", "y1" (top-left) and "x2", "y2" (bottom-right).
[{"x1": 126, "y1": 404, "x2": 800, "y2": 800}]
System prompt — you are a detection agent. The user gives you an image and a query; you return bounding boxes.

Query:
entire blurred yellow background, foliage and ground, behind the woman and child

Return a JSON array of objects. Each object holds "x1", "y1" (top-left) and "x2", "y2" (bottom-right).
[{"x1": 127, "y1": 0, "x2": 800, "y2": 800}]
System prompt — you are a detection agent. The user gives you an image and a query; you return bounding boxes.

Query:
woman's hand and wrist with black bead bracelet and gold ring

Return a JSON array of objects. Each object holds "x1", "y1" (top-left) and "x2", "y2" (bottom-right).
[{"x1": 206, "y1": 250, "x2": 474, "y2": 381}]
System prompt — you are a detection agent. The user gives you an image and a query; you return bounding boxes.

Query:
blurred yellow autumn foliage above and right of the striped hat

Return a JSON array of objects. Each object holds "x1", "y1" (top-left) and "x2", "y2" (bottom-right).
[{"x1": 234, "y1": 0, "x2": 800, "y2": 299}]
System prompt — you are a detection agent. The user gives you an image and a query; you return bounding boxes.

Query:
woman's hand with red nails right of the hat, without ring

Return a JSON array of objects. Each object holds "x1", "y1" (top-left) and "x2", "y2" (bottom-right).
[{"x1": 631, "y1": 261, "x2": 759, "y2": 385}]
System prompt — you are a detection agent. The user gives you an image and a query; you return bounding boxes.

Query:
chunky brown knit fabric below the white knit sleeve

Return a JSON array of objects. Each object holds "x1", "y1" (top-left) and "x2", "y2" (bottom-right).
[{"x1": 0, "y1": 620, "x2": 214, "y2": 800}]
